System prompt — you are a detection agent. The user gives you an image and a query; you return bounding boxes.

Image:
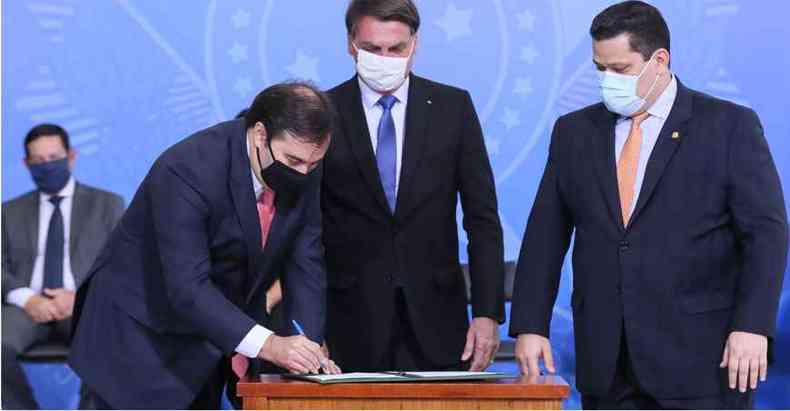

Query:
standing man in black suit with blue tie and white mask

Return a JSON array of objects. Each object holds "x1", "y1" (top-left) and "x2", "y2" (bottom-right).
[{"x1": 322, "y1": 0, "x2": 504, "y2": 371}]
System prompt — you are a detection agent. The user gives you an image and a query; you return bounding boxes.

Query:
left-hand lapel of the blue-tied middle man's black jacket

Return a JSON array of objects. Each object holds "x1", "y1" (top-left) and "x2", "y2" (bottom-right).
[{"x1": 341, "y1": 77, "x2": 390, "y2": 213}]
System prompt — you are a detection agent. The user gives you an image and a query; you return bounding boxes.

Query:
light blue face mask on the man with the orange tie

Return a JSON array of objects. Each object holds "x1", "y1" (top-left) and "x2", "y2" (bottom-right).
[{"x1": 598, "y1": 54, "x2": 658, "y2": 117}]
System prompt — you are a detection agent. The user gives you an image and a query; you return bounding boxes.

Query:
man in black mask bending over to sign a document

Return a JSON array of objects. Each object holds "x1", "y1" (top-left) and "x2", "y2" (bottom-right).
[{"x1": 74, "y1": 83, "x2": 339, "y2": 409}]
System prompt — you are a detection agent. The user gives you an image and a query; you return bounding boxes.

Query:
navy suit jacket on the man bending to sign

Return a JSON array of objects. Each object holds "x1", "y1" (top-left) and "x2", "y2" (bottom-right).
[{"x1": 69, "y1": 120, "x2": 325, "y2": 409}]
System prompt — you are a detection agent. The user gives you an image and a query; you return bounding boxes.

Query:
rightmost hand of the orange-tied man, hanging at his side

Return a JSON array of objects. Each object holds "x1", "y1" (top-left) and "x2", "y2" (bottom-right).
[{"x1": 719, "y1": 331, "x2": 768, "y2": 392}]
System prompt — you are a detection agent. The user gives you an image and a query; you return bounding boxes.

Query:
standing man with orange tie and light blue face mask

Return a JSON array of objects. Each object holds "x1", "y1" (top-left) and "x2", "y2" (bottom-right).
[{"x1": 510, "y1": 1, "x2": 788, "y2": 409}]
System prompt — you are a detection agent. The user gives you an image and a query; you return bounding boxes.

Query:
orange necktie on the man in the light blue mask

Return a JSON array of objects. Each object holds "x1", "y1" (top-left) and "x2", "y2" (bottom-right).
[{"x1": 617, "y1": 112, "x2": 649, "y2": 226}]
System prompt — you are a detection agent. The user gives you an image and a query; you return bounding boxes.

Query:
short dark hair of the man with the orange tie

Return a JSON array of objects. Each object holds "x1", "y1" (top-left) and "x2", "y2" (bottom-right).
[{"x1": 590, "y1": 0, "x2": 669, "y2": 60}]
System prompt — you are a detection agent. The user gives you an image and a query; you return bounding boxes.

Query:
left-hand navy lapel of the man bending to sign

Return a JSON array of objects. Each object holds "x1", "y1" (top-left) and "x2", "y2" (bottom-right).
[{"x1": 229, "y1": 121, "x2": 261, "y2": 298}]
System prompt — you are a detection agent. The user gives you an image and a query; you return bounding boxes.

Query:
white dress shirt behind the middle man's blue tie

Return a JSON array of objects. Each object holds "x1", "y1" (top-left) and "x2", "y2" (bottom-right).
[{"x1": 359, "y1": 77, "x2": 409, "y2": 196}]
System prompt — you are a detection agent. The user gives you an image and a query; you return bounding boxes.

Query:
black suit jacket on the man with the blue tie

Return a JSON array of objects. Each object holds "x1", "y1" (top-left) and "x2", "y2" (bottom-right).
[{"x1": 322, "y1": 75, "x2": 505, "y2": 371}]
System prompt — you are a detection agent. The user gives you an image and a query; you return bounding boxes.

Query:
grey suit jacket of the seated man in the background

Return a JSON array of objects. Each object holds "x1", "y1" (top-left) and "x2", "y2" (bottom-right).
[{"x1": 2, "y1": 183, "x2": 124, "y2": 303}]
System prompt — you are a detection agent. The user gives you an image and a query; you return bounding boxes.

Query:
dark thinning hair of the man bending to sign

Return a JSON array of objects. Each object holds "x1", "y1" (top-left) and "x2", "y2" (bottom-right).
[{"x1": 244, "y1": 81, "x2": 335, "y2": 143}]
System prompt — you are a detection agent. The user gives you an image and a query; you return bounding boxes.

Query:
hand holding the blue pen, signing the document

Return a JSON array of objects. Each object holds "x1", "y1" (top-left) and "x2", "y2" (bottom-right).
[{"x1": 258, "y1": 335, "x2": 329, "y2": 374}]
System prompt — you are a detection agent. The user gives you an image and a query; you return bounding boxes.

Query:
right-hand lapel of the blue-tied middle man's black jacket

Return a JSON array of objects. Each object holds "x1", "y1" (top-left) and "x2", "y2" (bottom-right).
[{"x1": 395, "y1": 75, "x2": 431, "y2": 222}]
